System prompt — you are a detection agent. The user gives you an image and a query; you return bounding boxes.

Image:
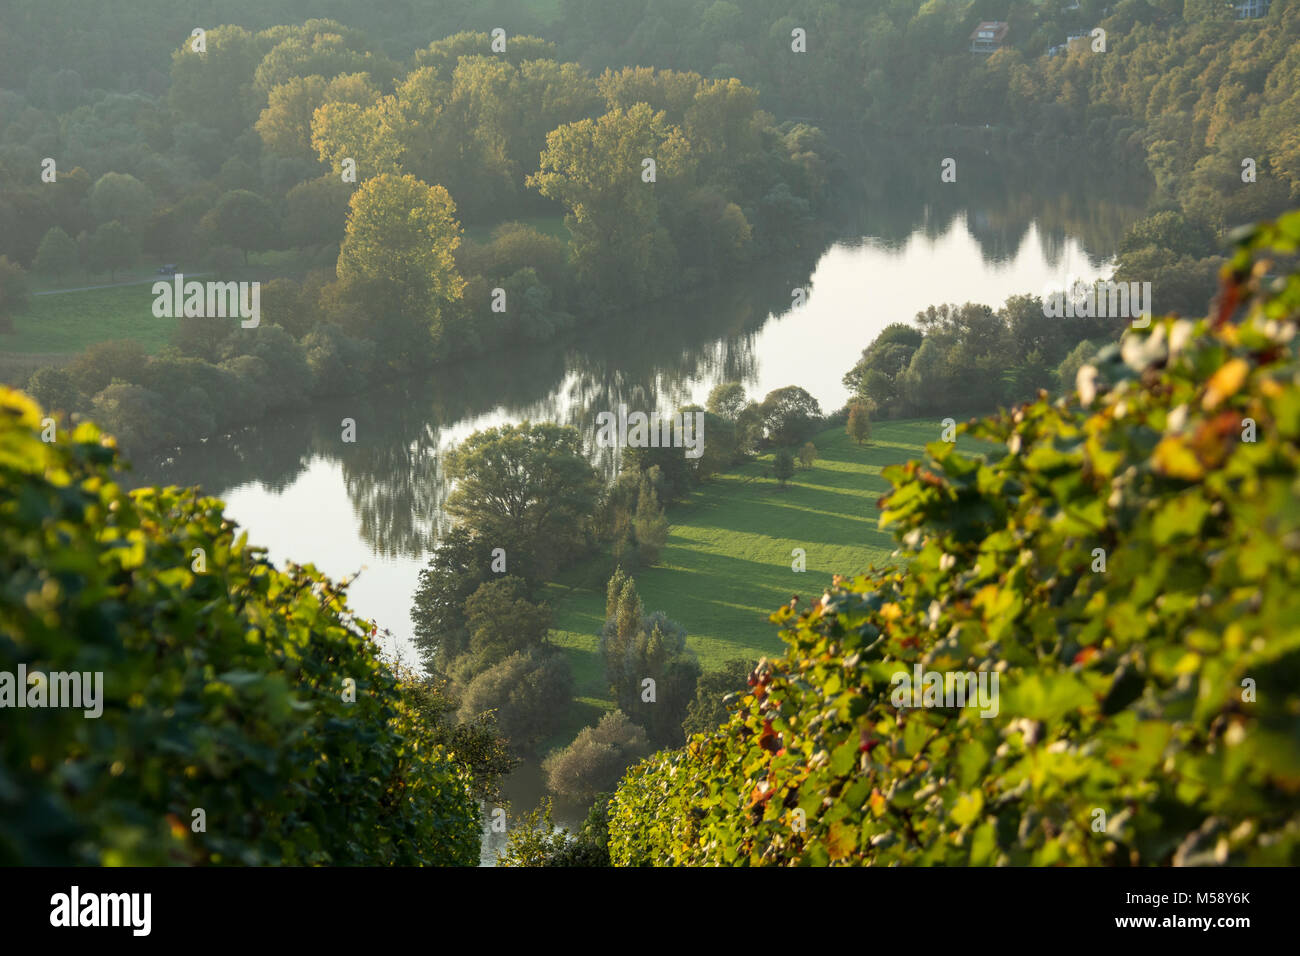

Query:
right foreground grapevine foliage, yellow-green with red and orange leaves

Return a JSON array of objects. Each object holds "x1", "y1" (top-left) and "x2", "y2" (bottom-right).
[{"x1": 610, "y1": 213, "x2": 1300, "y2": 865}]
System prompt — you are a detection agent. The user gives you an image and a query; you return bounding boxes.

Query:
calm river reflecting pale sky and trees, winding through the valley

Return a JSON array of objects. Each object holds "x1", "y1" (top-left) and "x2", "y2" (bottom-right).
[{"x1": 130, "y1": 140, "x2": 1144, "y2": 862}]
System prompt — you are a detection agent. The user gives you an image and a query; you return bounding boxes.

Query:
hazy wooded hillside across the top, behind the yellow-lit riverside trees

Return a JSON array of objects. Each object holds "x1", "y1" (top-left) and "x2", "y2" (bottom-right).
[{"x1": 0, "y1": 0, "x2": 1300, "y2": 222}]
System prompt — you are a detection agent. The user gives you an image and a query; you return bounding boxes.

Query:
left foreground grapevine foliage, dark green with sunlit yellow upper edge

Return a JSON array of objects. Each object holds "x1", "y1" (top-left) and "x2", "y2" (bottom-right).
[{"x1": 0, "y1": 386, "x2": 478, "y2": 865}]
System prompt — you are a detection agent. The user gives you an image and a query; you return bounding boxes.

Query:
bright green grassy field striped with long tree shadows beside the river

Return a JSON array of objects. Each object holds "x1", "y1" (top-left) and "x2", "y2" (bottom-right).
[{"x1": 546, "y1": 420, "x2": 975, "y2": 732}]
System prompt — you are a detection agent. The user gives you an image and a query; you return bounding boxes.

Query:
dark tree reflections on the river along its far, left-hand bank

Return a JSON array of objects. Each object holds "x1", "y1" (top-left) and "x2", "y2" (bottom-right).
[{"x1": 125, "y1": 245, "x2": 826, "y2": 557}]
